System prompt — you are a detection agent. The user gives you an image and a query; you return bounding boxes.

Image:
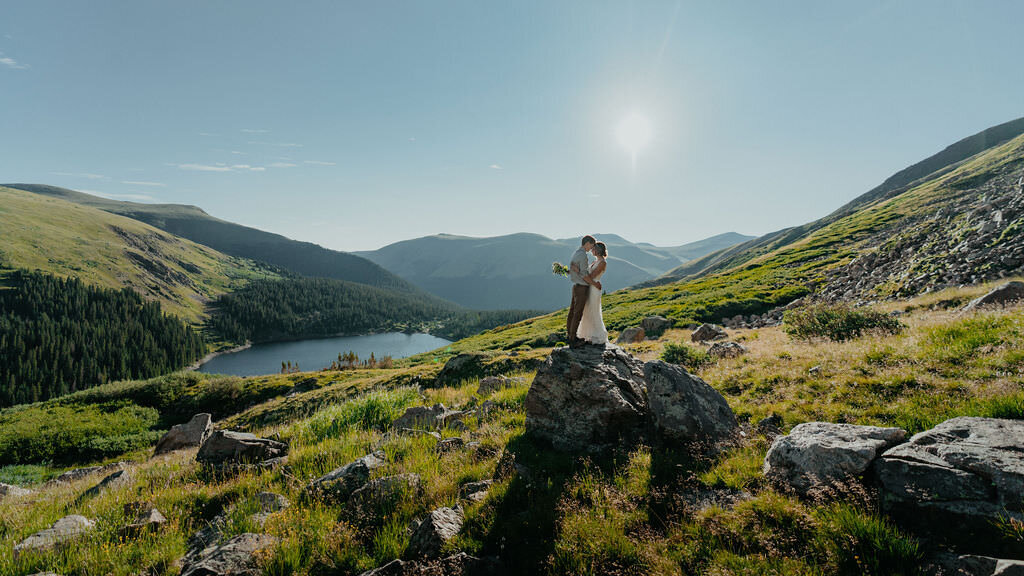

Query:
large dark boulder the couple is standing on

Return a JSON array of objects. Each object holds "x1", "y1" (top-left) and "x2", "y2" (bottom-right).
[{"x1": 525, "y1": 344, "x2": 647, "y2": 452}]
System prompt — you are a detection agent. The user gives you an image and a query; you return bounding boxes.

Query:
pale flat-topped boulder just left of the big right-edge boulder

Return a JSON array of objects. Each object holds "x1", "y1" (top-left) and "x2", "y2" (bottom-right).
[{"x1": 764, "y1": 416, "x2": 906, "y2": 496}]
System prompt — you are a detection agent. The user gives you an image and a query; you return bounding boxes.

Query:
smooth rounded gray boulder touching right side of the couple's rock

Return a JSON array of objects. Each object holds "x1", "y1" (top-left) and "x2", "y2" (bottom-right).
[{"x1": 643, "y1": 360, "x2": 737, "y2": 449}]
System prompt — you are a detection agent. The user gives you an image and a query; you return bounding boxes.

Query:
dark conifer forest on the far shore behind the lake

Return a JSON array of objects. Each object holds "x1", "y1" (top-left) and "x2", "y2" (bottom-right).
[{"x1": 207, "y1": 278, "x2": 537, "y2": 342}]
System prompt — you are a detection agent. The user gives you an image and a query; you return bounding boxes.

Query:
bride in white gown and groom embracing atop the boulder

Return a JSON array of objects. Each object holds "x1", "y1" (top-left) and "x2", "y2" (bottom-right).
[{"x1": 565, "y1": 236, "x2": 608, "y2": 347}]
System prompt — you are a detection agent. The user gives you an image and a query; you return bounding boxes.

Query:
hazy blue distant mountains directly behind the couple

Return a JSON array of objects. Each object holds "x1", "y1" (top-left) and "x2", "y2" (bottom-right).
[{"x1": 358, "y1": 233, "x2": 750, "y2": 310}]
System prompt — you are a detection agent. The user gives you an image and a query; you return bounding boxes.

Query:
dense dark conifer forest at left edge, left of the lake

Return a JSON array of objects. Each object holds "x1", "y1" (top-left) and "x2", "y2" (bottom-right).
[{"x1": 0, "y1": 271, "x2": 206, "y2": 406}]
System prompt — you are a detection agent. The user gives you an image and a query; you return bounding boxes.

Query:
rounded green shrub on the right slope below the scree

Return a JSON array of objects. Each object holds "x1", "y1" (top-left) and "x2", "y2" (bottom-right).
[{"x1": 783, "y1": 304, "x2": 904, "y2": 342}]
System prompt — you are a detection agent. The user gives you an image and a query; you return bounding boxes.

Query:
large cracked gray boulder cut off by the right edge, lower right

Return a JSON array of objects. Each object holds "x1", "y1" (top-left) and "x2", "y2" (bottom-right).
[{"x1": 874, "y1": 417, "x2": 1024, "y2": 556}]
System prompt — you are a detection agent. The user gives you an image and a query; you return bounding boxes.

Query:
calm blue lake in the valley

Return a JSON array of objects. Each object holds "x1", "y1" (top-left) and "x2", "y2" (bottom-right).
[{"x1": 199, "y1": 332, "x2": 452, "y2": 376}]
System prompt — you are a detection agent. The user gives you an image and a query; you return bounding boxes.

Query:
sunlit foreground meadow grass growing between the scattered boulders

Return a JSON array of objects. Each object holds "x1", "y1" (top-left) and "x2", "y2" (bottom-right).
[{"x1": 0, "y1": 280, "x2": 1024, "y2": 576}]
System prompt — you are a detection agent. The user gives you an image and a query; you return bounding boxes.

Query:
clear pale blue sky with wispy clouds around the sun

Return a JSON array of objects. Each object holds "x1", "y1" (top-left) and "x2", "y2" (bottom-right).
[{"x1": 0, "y1": 0, "x2": 1024, "y2": 250}]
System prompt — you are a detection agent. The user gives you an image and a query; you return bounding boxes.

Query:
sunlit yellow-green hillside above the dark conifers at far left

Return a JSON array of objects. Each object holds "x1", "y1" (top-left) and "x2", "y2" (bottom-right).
[{"x1": 0, "y1": 187, "x2": 278, "y2": 323}]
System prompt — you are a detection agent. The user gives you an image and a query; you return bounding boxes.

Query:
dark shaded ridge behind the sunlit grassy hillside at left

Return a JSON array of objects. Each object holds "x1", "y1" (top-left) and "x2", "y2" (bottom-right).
[{"x1": 5, "y1": 183, "x2": 418, "y2": 292}]
